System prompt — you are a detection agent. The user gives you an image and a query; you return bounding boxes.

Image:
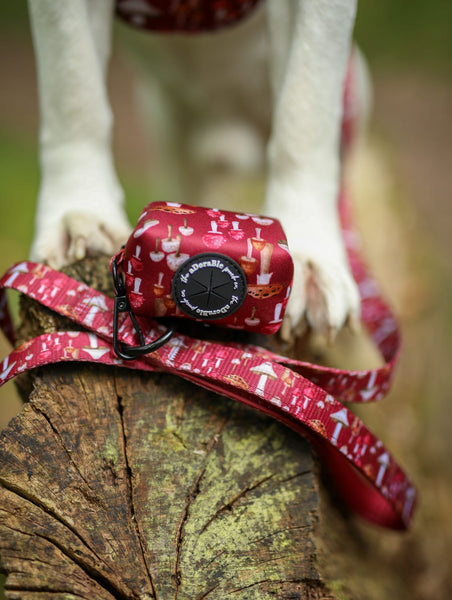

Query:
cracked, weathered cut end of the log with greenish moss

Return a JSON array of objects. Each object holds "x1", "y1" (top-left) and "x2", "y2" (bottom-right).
[{"x1": 0, "y1": 262, "x2": 333, "y2": 600}]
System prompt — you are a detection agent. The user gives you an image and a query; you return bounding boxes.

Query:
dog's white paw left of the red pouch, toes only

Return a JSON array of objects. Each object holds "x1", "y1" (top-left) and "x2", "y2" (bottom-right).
[{"x1": 31, "y1": 211, "x2": 131, "y2": 268}]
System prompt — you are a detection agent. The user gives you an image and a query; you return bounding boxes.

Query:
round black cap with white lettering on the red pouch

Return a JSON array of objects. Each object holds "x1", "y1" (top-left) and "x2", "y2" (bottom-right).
[{"x1": 172, "y1": 252, "x2": 247, "y2": 320}]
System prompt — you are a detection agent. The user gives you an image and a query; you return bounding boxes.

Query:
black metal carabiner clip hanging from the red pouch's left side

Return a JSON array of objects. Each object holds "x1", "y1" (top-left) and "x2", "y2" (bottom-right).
[{"x1": 111, "y1": 257, "x2": 174, "y2": 360}]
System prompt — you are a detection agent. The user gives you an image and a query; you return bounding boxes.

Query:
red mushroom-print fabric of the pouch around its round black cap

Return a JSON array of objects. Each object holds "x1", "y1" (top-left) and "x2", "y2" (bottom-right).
[{"x1": 117, "y1": 202, "x2": 293, "y2": 334}]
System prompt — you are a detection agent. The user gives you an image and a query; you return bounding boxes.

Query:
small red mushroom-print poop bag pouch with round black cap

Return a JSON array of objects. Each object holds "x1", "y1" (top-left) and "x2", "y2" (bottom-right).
[{"x1": 111, "y1": 202, "x2": 293, "y2": 358}]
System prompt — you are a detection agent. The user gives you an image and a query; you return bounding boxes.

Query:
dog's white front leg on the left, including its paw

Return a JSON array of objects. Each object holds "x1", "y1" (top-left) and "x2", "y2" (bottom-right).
[{"x1": 29, "y1": 0, "x2": 129, "y2": 266}]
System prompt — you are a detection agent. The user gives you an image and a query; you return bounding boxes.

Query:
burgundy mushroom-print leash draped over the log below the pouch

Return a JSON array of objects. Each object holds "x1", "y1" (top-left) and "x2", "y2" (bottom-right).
[{"x1": 0, "y1": 196, "x2": 416, "y2": 529}]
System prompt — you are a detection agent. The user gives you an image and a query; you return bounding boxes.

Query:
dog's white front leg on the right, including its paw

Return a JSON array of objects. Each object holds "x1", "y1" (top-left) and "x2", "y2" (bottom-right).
[{"x1": 265, "y1": 0, "x2": 359, "y2": 336}]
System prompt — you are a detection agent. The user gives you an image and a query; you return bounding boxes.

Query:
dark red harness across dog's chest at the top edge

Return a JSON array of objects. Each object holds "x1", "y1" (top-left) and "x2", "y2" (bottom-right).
[{"x1": 116, "y1": 0, "x2": 260, "y2": 33}]
